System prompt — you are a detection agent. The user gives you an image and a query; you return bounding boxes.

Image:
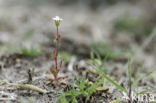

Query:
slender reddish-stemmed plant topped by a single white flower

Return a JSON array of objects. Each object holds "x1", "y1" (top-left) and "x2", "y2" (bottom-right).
[{"x1": 47, "y1": 16, "x2": 66, "y2": 85}]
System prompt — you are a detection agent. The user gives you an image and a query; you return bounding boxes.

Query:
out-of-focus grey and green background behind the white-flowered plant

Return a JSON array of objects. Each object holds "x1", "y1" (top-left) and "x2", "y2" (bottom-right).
[{"x1": 0, "y1": 0, "x2": 156, "y2": 67}]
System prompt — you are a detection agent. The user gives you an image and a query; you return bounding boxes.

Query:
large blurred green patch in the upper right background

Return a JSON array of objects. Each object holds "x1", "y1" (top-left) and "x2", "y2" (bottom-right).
[{"x1": 113, "y1": 15, "x2": 153, "y2": 37}]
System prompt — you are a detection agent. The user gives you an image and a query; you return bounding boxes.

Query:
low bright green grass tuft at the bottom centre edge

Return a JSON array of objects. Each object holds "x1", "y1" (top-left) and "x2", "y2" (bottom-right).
[{"x1": 55, "y1": 76, "x2": 103, "y2": 103}]
